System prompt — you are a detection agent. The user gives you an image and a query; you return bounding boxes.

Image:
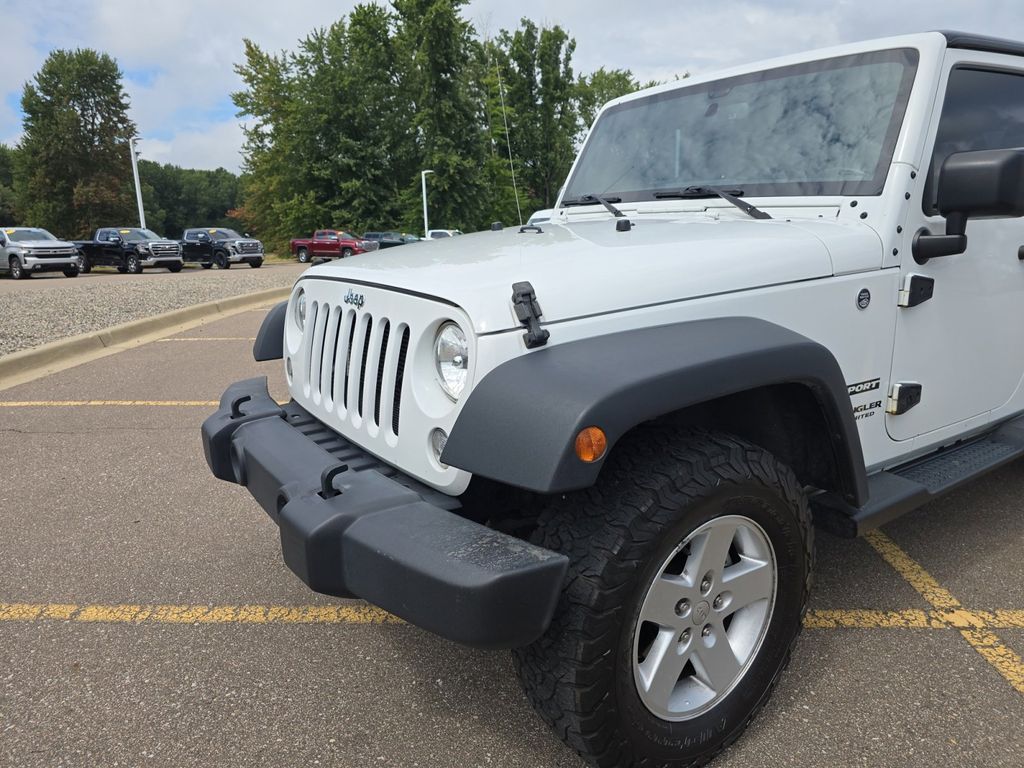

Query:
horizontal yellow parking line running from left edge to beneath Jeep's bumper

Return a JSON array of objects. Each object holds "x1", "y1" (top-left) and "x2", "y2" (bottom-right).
[{"x1": 0, "y1": 603, "x2": 402, "y2": 624}]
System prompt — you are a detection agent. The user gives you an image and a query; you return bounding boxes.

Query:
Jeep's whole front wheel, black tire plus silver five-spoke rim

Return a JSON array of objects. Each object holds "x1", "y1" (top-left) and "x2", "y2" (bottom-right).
[{"x1": 514, "y1": 428, "x2": 813, "y2": 768}]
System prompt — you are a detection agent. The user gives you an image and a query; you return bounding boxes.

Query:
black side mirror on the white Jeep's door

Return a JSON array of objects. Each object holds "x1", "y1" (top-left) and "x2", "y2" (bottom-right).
[{"x1": 913, "y1": 148, "x2": 1024, "y2": 264}]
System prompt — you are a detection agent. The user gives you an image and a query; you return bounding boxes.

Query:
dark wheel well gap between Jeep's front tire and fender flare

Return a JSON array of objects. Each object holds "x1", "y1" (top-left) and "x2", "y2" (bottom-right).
[{"x1": 630, "y1": 384, "x2": 843, "y2": 490}]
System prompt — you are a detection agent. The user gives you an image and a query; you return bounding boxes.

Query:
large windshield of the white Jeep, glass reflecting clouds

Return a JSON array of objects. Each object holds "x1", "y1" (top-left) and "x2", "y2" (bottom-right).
[{"x1": 563, "y1": 48, "x2": 918, "y2": 202}]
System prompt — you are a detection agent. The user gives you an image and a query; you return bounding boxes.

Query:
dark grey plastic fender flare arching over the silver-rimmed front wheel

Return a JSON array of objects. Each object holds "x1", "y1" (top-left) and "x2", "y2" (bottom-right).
[{"x1": 441, "y1": 317, "x2": 867, "y2": 506}]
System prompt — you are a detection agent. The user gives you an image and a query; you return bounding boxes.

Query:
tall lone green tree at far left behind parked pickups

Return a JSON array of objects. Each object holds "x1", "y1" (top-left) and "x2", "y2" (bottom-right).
[{"x1": 15, "y1": 49, "x2": 135, "y2": 237}]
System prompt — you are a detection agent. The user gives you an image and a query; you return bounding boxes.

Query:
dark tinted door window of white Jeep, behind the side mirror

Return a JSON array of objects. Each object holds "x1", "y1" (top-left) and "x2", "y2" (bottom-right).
[{"x1": 923, "y1": 67, "x2": 1024, "y2": 214}]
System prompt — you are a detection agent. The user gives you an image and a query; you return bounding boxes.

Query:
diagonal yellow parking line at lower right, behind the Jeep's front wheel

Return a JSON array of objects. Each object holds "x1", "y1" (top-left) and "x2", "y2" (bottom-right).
[{"x1": 864, "y1": 530, "x2": 1024, "y2": 693}]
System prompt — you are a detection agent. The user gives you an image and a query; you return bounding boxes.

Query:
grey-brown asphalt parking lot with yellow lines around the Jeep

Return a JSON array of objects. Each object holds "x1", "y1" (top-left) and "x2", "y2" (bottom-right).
[{"x1": 0, "y1": 309, "x2": 1024, "y2": 768}]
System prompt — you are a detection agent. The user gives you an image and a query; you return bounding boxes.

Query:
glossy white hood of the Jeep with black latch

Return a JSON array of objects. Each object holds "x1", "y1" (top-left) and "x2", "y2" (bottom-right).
[{"x1": 309, "y1": 215, "x2": 882, "y2": 333}]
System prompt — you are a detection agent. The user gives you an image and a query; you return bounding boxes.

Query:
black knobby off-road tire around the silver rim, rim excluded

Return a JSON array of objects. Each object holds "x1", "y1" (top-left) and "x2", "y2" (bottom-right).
[{"x1": 513, "y1": 427, "x2": 814, "y2": 768}]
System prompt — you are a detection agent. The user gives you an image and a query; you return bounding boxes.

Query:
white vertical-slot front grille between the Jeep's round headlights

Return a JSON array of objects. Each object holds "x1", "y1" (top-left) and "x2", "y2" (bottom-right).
[{"x1": 306, "y1": 301, "x2": 410, "y2": 436}]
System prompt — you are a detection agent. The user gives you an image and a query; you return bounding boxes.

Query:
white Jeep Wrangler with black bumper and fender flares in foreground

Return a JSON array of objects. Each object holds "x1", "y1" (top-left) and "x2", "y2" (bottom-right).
[{"x1": 203, "y1": 33, "x2": 1024, "y2": 766}]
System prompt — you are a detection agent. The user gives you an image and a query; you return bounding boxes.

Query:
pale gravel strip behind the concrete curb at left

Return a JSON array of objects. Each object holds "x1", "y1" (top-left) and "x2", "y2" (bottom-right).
[{"x1": 0, "y1": 264, "x2": 303, "y2": 356}]
